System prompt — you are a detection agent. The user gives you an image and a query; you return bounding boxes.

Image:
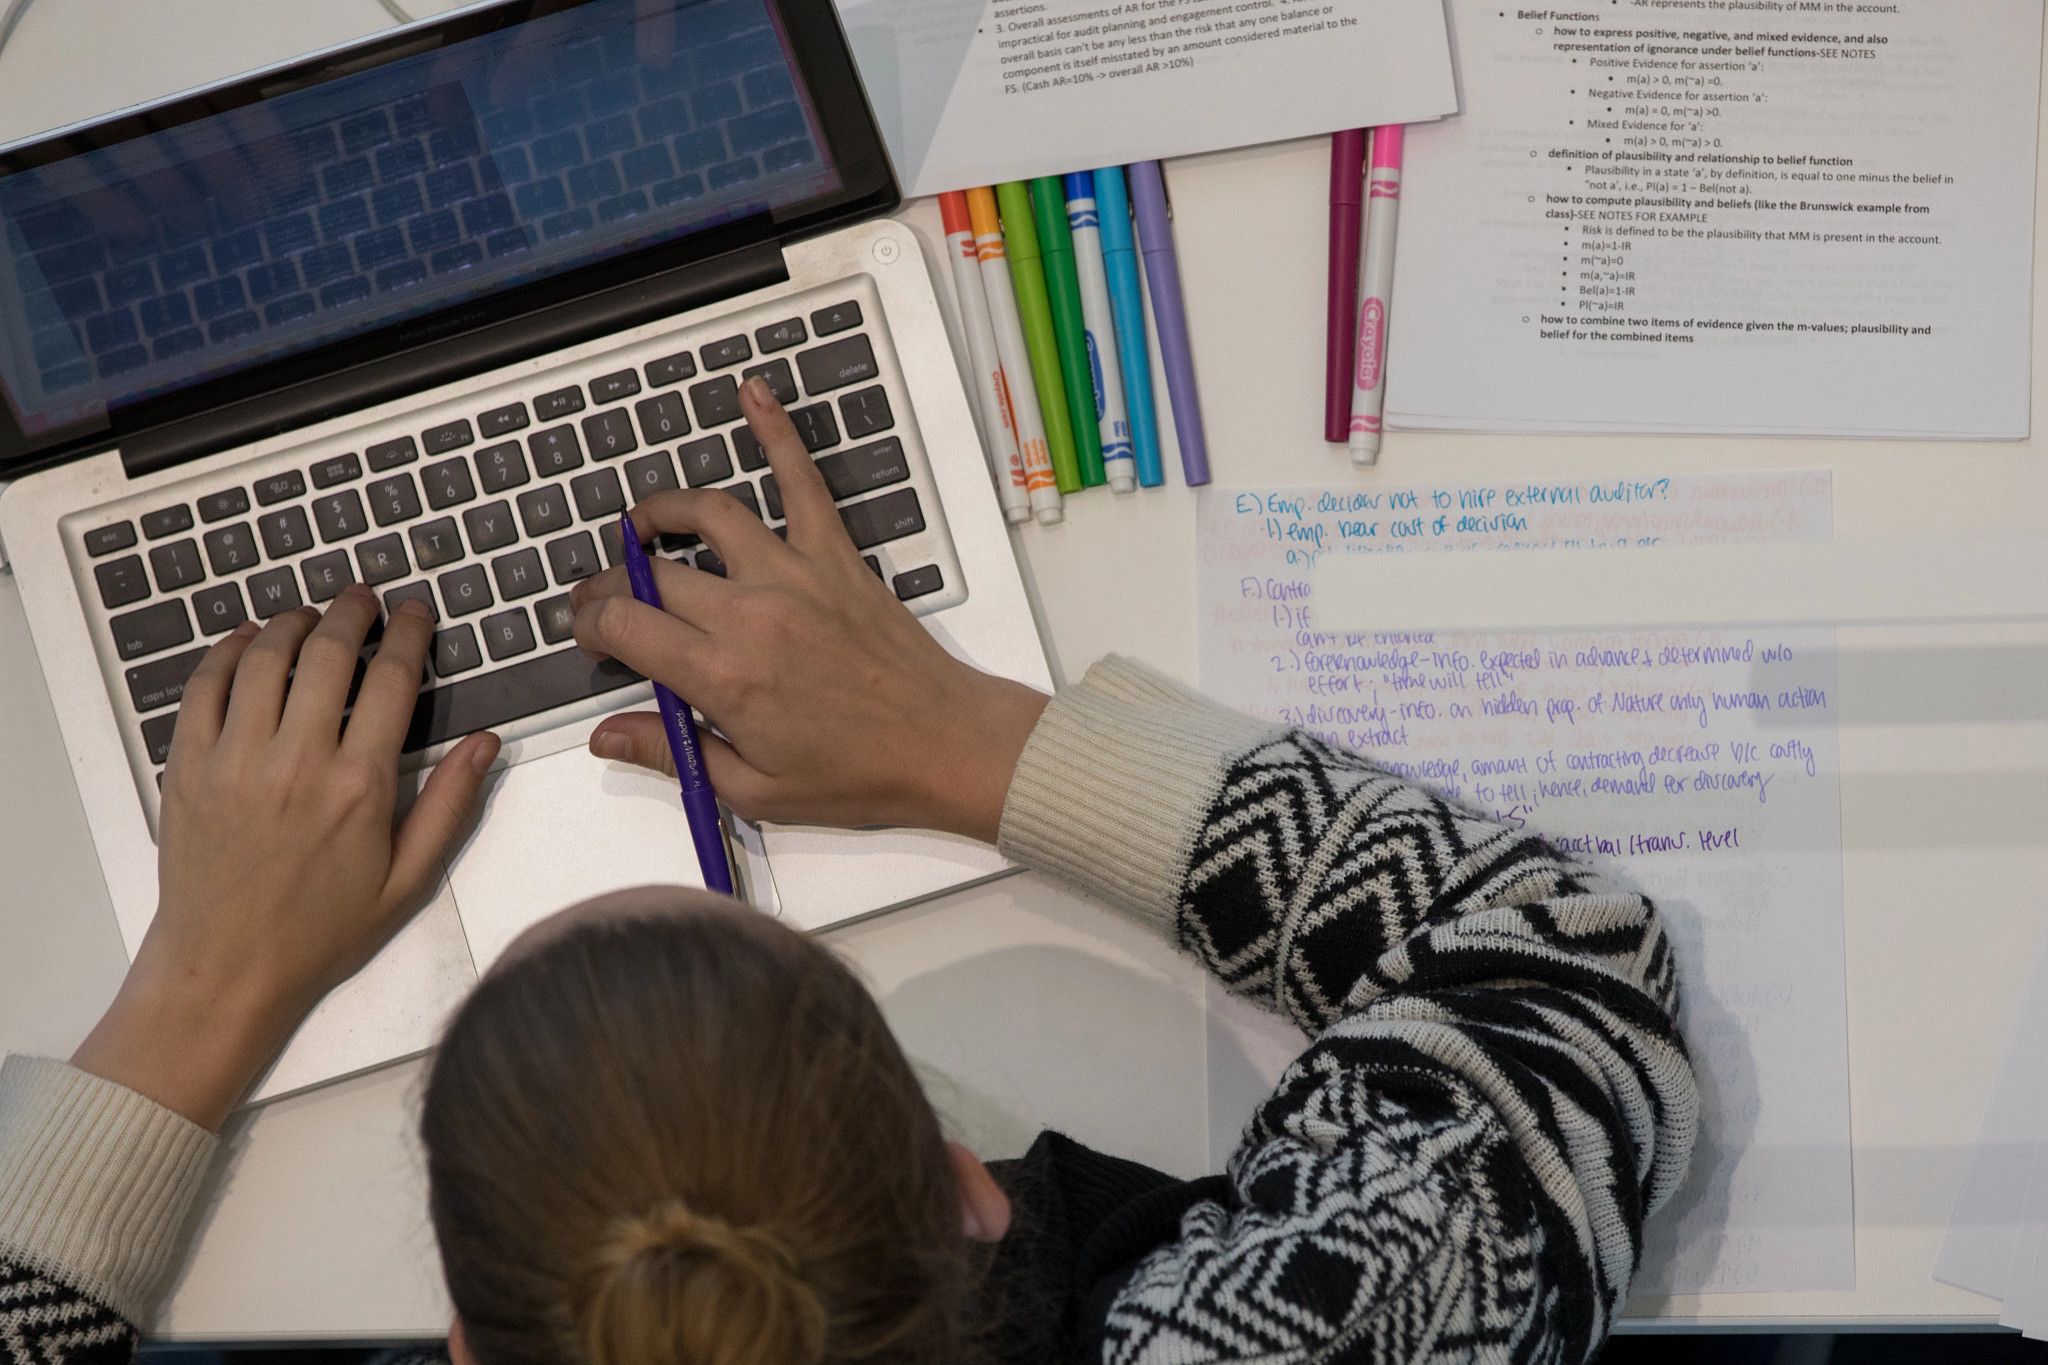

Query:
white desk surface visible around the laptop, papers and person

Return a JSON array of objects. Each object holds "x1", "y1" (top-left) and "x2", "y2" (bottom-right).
[{"x1": 0, "y1": 0, "x2": 2048, "y2": 1338}]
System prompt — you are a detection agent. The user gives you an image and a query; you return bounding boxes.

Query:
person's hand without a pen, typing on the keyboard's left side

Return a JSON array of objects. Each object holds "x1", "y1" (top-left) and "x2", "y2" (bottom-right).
[{"x1": 72, "y1": 585, "x2": 498, "y2": 1128}]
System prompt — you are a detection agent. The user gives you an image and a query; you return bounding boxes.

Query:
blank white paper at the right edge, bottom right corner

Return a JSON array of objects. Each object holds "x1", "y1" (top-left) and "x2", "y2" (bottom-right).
[{"x1": 1933, "y1": 935, "x2": 2048, "y2": 1340}]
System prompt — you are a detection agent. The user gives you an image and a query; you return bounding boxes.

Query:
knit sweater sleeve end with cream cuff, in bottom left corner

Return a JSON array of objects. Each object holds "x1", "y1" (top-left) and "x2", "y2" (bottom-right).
[{"x1": 0, "y1": 1056, "x2": 219, "y2": 1365}]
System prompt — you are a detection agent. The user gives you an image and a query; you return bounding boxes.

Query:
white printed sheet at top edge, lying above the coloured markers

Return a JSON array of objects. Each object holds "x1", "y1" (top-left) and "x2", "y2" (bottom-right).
[{"x1": 838, "y1": 0, "x2": 1458, "y2": 197}]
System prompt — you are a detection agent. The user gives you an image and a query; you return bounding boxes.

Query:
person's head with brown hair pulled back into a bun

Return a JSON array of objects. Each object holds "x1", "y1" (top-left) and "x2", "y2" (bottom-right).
[{"x1": 420, "y1": 890, "x2": 1008, "y2": 1365}]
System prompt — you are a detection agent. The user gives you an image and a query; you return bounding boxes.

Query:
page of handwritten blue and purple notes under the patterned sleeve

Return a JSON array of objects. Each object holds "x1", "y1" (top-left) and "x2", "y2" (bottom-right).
[{"x1": 1198, "y1": 473, "x2": 1855, "y2": 1293}]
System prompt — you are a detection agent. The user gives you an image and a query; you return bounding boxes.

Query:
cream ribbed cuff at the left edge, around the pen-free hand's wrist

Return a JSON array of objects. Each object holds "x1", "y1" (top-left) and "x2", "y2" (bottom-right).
[{"x1": 0, "y1": 1056, "x2": 219, "y2": 1326}]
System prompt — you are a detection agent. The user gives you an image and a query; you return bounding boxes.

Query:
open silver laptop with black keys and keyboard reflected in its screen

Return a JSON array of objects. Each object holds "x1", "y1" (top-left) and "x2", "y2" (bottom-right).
[{"x1": 0, "y1": 0, "x2": 1051, "y2": 1099}]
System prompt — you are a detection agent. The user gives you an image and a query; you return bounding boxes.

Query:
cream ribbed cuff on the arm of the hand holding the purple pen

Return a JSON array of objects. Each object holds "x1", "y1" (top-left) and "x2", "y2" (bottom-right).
[{"x1": 997, "y1": 657, "x2": 1284, "y2": 931}]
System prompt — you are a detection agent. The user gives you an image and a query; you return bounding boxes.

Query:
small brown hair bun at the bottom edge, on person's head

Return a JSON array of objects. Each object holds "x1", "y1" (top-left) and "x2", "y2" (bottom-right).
[{"x1": 580, "y1": 1199, "x2": 825, "y2": 1365}]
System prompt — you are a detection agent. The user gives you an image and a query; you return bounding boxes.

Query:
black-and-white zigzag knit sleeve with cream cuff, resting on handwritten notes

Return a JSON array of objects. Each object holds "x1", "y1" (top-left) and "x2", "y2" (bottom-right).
[{"x1": 1001, "y1": 659, "x2": 1698, "y2": 1365}]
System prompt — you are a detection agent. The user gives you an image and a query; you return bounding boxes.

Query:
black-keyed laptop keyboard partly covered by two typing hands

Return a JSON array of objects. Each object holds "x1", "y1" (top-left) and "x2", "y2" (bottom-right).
[{"x1": 72, "y1": 284, "x2": 965, "y2": 812}]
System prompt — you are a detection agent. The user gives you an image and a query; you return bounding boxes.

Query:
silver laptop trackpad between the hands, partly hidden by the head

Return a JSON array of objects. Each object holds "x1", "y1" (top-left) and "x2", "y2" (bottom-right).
[{"x1": 449, "y1": 749, "x2": 705, "y2": 972}]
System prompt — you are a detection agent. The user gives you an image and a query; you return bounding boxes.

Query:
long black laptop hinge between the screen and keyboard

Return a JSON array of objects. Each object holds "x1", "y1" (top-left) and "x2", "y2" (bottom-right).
[{"x1": 121, "y1": 241, "x2": 788, "y2": 479}]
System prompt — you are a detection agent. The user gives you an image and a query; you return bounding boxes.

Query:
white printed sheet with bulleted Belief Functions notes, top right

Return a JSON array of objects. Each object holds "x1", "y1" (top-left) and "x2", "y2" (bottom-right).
[{"x1": 1386, "y1": 0, "x2": 2042, "y2": 438}]
